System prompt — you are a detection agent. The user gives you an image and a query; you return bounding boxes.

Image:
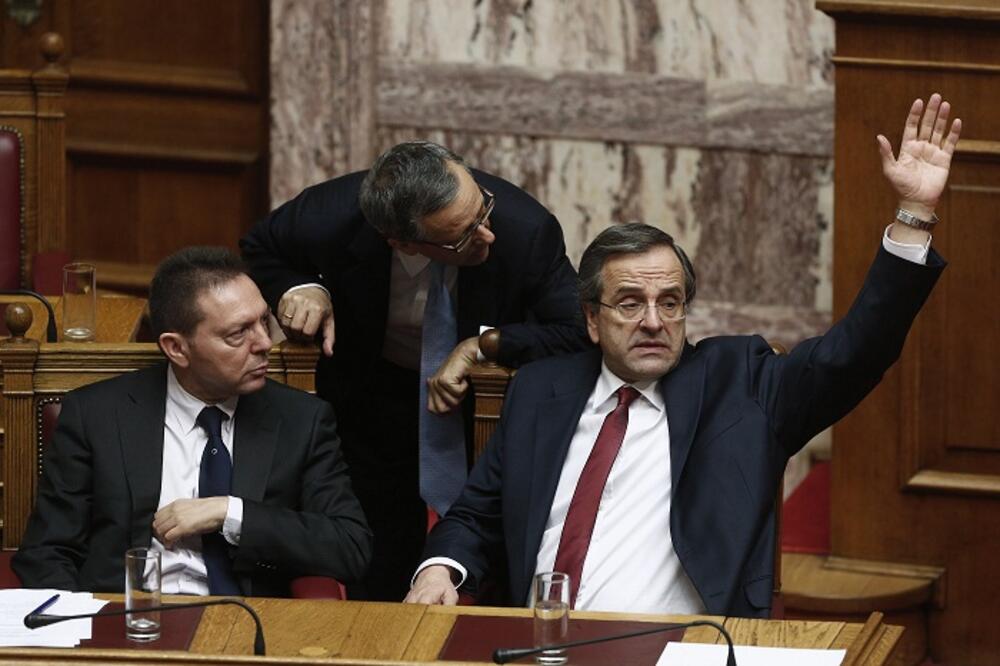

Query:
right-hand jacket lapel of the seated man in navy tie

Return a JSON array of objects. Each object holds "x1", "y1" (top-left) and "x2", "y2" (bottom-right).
[{"x1": 232, "y1": 385, "x2": 281, "y2": 502}]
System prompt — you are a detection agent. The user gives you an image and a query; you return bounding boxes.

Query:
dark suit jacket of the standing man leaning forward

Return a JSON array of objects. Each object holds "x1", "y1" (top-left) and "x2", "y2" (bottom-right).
[{"x1": 240, "y1": 170, "x2": 590, "y2": 417}]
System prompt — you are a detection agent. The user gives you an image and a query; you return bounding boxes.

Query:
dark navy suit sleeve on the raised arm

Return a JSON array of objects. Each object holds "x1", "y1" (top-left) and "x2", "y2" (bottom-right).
[{"x1": 749, "y1": 248, "x2": 945, "y2": 455}]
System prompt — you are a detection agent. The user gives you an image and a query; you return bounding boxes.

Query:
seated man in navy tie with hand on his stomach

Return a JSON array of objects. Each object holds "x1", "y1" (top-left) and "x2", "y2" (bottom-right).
[{"x1": 13, "y1": 248, "x2": 372, "y2": 596}]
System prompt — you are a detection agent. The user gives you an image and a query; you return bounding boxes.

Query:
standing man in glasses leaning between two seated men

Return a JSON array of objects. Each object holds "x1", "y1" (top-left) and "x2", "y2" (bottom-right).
[{"x1": 242, "y1": 142, "x2": 589, "y2": 601}]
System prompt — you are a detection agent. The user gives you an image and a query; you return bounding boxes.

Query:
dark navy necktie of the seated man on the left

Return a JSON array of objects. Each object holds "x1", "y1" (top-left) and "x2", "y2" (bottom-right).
[{"x1": 198, "y1": 407, "x2": 240, "y2": 596}]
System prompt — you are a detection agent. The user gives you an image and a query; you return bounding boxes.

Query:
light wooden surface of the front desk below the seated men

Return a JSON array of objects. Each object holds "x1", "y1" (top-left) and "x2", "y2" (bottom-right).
[{"x1": 0, "y1": 596, "x2": 902, "y2": 665}]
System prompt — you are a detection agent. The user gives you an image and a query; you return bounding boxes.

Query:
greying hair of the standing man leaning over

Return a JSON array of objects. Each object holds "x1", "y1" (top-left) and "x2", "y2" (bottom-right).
[{"x1": 358, "y1": 141, "x2": 468, "y2": 241}]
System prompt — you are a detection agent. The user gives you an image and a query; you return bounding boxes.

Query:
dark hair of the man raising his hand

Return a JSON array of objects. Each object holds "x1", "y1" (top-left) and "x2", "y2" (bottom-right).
[{"x1": 577, "y1": 222, "x2": 696, "y2": 306}]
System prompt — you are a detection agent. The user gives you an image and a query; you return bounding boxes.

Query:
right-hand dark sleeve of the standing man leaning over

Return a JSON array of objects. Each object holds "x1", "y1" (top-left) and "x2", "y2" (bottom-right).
[{"x1": 498, "y1": 215, "x2": 590, "y2": 367}]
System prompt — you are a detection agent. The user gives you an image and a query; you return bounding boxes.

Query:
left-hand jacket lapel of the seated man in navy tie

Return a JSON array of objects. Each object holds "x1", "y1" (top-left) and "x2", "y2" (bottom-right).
[{"x1": 116, "y1": 363, "x2": 167, "y2": 547}]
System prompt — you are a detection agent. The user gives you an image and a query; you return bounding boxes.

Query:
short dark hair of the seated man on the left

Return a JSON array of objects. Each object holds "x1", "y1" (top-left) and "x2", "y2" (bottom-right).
[{"x1": 149, "y1": 247, "x2": 247, "y2": 338}]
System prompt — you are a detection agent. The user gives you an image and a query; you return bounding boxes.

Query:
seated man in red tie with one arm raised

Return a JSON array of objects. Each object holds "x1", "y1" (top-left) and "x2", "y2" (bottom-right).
[{"x1": 407, "y1": 95, "x2": 961, "y2": 616}]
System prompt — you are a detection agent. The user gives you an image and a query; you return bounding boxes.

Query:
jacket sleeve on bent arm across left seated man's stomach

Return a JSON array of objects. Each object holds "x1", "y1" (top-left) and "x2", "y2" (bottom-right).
[{"x1": 235, "y1": 401, "x2": 372, "y2": 582}]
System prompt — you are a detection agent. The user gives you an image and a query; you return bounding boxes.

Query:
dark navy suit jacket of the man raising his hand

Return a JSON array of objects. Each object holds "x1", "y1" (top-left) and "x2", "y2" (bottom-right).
[{"x1": 425, "y1": 249, "x2": 944, "y2": 617}]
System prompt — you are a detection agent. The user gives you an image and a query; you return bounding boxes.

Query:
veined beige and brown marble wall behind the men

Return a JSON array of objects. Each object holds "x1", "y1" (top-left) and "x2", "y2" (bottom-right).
[{"x1": 271, "y1": 0, "x2": 833, "y2": 345}]
